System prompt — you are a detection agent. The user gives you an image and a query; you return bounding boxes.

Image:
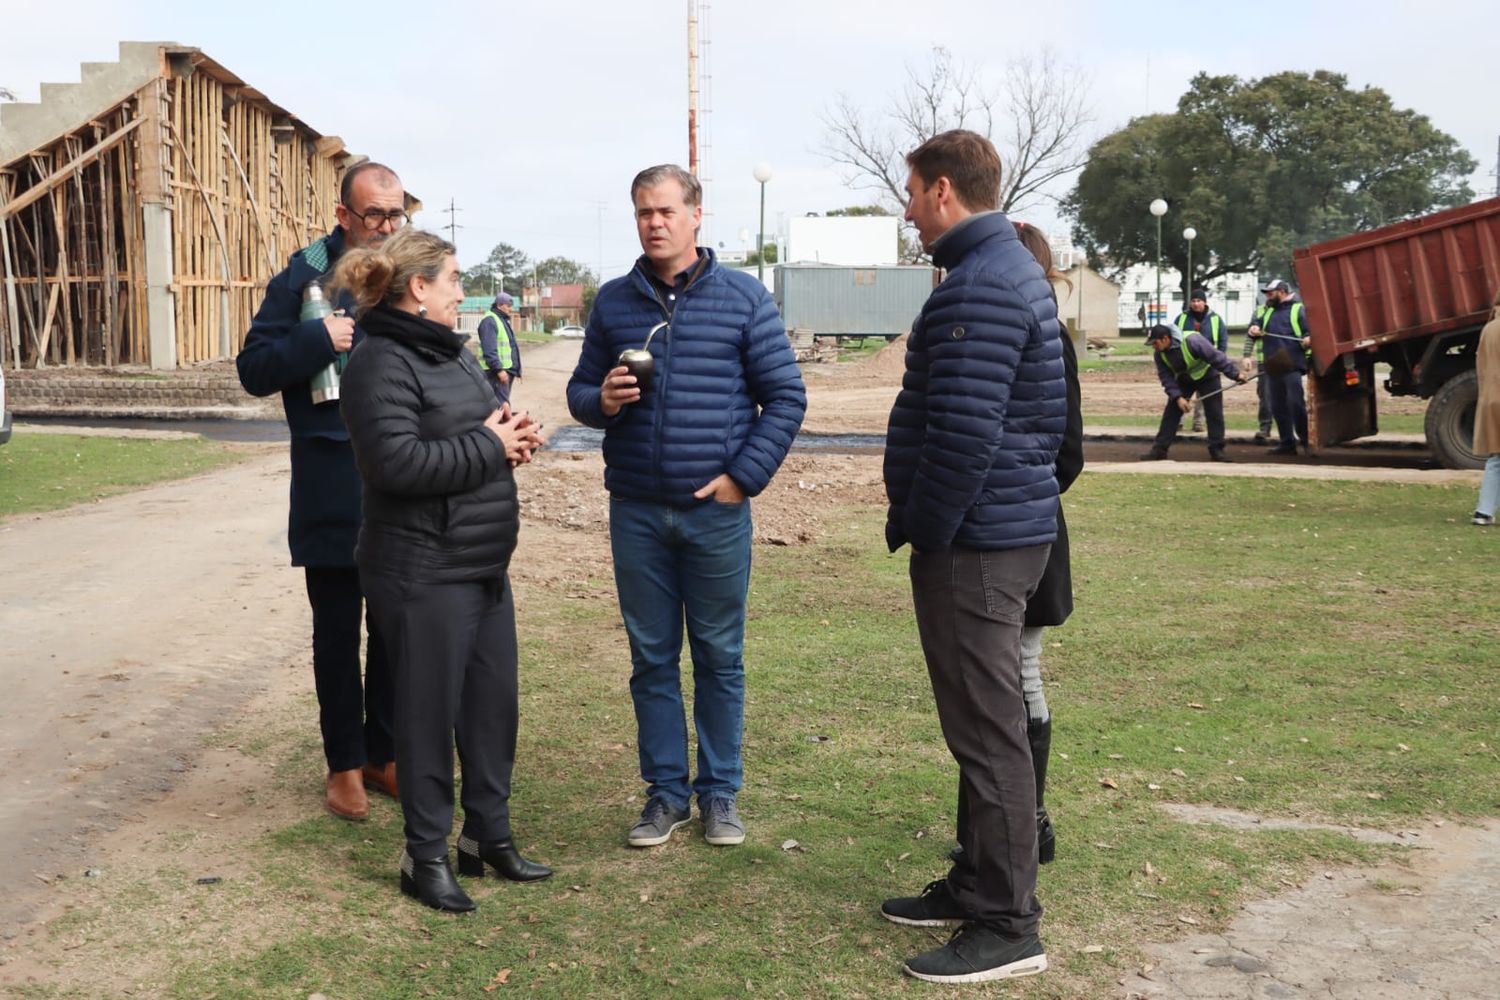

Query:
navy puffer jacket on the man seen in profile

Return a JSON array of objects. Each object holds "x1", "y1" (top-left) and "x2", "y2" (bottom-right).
[{"x1": 885, "y1": 211, "x2": 1068, "y2": 552}]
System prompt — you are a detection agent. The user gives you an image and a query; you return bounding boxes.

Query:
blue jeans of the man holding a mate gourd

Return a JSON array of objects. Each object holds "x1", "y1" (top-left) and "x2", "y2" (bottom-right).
[{"x1": 609, "y1": 496, "x2": 750, "y2": 808}]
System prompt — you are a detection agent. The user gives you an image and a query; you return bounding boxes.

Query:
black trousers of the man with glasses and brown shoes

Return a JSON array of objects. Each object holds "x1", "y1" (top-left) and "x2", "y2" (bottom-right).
[{"x1": 306, "y1": 567, "x2": 395, "y2": 771}]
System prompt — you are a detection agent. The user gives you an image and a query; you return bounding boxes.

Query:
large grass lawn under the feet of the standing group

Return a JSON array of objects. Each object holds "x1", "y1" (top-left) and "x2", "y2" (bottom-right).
[{"x1": 20, "y1": 474, "x2": 1500, "y2": 1000}]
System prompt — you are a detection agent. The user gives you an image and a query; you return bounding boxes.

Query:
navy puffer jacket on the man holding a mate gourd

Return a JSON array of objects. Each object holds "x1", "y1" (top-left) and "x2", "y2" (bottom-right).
[{"x1": 567, "y1": 247, "x2": 807, "y2": 507}]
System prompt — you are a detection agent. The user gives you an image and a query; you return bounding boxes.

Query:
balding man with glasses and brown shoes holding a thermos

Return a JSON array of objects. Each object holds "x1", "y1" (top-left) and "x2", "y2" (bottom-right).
[{"x1": 236, "y1": 162, "x2": 410, "y2": 820}]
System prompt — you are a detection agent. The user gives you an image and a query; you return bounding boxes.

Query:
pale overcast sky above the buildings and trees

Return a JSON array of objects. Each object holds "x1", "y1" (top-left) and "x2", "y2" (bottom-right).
[{"x1": 0, "y1": 0, "x2": 1500, "y2": 277}]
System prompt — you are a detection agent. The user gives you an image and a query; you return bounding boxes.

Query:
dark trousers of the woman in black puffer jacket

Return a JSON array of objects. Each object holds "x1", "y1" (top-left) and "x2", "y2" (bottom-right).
[{"x1": 365, "y1": 573, "x2": 518, "y2": 861}]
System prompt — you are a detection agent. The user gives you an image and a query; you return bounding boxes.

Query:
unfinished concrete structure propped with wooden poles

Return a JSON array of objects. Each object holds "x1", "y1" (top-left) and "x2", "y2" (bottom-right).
[{"x1": 0, "y1": 42, "x2": 365, "y2": 369}]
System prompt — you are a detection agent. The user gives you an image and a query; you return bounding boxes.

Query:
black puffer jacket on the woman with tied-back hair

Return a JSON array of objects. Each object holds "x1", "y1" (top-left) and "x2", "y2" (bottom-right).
[{"x1": 339, "y1": 306, "x2": 521, "y2": 583}]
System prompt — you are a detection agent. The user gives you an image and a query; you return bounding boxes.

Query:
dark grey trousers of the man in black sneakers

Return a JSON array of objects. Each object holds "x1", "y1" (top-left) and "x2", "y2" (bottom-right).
[{"x1": 911, "y1": 546, "x2": 1052, "y2": 937}]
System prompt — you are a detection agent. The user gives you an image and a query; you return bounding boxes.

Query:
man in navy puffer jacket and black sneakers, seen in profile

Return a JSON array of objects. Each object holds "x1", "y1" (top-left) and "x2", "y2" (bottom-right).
[{"x1": 881, "y1": 130, "x2": 1068, "y2": 982}]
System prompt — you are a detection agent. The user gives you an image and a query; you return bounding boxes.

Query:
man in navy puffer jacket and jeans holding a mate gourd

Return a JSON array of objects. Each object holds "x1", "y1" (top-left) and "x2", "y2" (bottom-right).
[{"x1": 567, "y1": 165, "x2": 807, "y2": 847}]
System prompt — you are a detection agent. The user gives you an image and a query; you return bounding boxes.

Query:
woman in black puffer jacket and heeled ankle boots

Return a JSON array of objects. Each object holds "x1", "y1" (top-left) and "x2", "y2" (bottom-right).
[{"x1": 335, "y1": 229, "x2": 552, "y2": 910}]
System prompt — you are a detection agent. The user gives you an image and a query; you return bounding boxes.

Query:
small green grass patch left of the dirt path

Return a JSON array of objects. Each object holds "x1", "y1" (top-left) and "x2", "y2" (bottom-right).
[{"x1": 0, "y1": 427, "x2": 245, "y2": 517}]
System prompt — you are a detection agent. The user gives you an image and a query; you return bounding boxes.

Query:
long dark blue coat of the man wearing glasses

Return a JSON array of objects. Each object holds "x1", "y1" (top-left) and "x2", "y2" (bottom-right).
[{"x1": 234, "y1": 229, "x2": 363, "y2": 567}]
